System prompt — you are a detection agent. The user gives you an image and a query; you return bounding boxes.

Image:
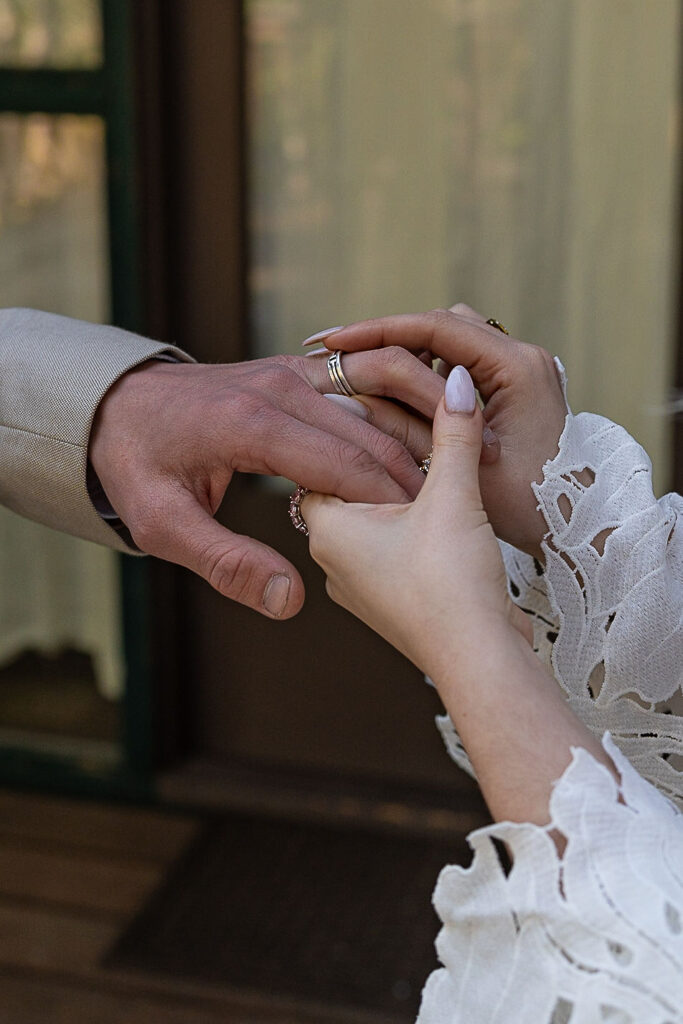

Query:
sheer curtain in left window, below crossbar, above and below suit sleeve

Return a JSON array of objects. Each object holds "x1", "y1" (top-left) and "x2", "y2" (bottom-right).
[{"x1": 0, "y1": 115, "x2": 124, "y2": 704}]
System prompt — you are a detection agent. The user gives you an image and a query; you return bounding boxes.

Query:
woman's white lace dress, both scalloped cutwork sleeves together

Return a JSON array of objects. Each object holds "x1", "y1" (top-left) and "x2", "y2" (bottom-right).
[{"x1": 418, "y1": 372, "x2": 683, "y2": 1024}]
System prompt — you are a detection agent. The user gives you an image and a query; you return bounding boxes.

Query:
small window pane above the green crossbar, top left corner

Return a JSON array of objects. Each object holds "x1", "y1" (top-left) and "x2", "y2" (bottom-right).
[{"x1": 0, "y1": 0, "x2": 102, "y2": 68}]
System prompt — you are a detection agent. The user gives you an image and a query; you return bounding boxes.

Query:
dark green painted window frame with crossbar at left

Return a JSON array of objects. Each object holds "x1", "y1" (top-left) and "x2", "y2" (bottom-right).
[{"x1": 0, "y1": 0, "x2": 155, "y2": 799}]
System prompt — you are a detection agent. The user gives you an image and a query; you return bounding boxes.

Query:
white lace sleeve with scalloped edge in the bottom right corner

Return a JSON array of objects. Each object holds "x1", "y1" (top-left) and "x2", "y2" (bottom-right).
[{"x1": 418, "y1": 735, "x2": 683, "y2": 1024}]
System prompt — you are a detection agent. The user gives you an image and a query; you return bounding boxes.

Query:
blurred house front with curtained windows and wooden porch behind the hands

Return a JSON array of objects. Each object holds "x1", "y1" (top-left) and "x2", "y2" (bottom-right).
[{"x1": 0, "y1": 0, "x2": 683, "y2": 1024}]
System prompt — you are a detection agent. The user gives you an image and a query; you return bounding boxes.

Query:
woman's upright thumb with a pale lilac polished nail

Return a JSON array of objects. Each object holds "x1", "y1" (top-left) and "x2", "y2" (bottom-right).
[{"x1": 423, "y1": 367, "x2": 483, "y2": 501}]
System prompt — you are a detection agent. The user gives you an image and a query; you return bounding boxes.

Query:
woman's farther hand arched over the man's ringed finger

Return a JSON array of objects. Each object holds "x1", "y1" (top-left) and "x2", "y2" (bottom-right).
[{"x1": 307, "y1": 303, "x2": 567, "y2": 558}]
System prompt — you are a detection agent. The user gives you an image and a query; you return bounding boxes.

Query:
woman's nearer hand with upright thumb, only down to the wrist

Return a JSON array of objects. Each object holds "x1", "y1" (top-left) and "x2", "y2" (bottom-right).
[{"x1": 301, "y1": 367, "x2": 530, "y2": 679}]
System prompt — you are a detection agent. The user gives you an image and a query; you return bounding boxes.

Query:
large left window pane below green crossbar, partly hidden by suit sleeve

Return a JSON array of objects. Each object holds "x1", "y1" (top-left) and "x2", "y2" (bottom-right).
[{"x1": 0, "y1": 115, "x2": 124, "y2": 756}]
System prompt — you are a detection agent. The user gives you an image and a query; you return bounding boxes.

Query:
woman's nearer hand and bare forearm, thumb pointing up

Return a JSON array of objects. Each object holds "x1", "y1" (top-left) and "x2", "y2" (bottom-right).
[{"x1": 301, "y1": 367, "x2": 615, "y2": 823}]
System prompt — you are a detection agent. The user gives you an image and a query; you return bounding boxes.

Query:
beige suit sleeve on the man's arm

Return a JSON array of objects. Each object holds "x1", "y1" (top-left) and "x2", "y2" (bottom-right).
[{"x1": 0, "y1": 309, "x2": 193, "y2": 553}]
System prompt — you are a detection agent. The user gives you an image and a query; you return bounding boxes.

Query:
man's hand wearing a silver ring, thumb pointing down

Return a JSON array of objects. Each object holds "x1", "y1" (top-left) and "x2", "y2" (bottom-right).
[{"x1": 89, "y1": 350, "x2": 443, "y2": 618}]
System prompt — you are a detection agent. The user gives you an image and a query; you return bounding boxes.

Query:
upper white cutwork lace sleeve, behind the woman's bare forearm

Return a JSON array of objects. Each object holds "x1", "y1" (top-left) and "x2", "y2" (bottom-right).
[{"x1": 437, "y1": 364, "x2": 683, "y2": 803}]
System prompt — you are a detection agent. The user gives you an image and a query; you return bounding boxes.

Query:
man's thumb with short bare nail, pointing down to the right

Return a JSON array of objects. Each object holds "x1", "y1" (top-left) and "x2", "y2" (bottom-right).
[{"x1": 132, "y1": 490, "x2": 304, "y2": 618}]
